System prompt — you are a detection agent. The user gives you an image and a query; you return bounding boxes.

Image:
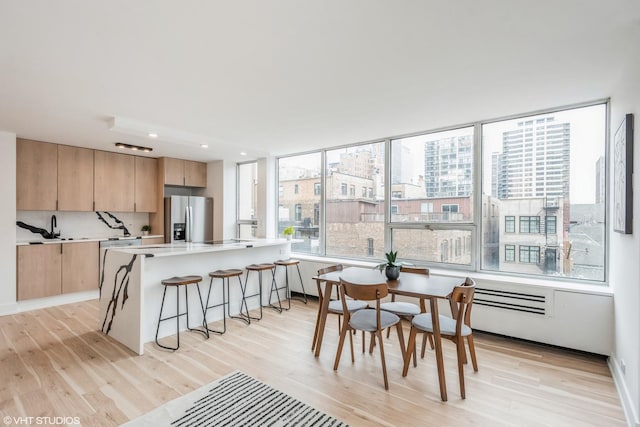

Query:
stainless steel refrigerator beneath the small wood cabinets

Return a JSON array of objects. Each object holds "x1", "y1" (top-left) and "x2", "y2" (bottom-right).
[{"x1": 164, "y1": 196, "x2": 213, "y2": 243}]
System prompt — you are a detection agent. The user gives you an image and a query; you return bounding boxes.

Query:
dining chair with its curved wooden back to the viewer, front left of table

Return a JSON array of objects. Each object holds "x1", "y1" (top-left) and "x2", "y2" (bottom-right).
[{"x1": 333, "y1": 279, "x2": 405, "y2": 390}]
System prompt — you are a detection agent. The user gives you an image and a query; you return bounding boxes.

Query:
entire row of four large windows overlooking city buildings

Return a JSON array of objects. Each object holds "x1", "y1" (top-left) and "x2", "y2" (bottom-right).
[{"x1": 278, "y1": 103, "x2": 607, "y2": 282}]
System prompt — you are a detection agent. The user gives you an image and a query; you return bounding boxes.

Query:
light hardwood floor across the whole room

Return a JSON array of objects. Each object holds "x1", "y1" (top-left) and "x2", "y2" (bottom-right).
[{"x1": 0, "y1": 301, "x2": 625, "y2": 427}]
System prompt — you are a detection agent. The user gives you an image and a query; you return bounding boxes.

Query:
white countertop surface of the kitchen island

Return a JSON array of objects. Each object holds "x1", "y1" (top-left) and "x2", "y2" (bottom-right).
[{"x1": 109, "y1": 239, "x2": 291, "y2": 257}]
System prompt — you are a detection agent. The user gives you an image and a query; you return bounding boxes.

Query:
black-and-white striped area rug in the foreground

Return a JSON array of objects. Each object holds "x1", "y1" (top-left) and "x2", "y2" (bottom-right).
[{"x1": 124, "y1": 371, "x2": 348, "y2": 427}]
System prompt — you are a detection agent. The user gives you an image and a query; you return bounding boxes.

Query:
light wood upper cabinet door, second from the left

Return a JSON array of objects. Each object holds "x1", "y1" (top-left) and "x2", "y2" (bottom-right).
[{"x1": 58, "y1": 145, "x2": 94, "y2": 212}]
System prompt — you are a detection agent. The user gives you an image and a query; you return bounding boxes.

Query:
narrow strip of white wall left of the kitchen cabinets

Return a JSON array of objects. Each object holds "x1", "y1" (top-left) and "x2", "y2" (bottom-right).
[{"x1": 0, "y1": 131, "x2": 16, "y2": 313}]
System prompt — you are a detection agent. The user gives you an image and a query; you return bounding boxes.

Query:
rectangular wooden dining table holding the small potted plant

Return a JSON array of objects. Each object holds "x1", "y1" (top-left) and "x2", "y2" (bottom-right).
[{"x1": 313, "y1": 267, "x2": 464, "y2": 401}]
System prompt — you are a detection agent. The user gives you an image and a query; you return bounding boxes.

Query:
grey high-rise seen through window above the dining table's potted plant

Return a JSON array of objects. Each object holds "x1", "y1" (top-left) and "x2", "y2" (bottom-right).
[{"x1": 424, "y1": 134, "x2": 473, "y2": 197}]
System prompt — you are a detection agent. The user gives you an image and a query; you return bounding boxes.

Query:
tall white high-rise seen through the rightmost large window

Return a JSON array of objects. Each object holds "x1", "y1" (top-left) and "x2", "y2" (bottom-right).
[{"x1": 493, "y1": 117, "x2": 570, "y2": 199}]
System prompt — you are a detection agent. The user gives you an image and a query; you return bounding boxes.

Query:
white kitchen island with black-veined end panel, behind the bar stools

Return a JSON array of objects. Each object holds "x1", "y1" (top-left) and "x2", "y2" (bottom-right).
[{"x1": 99, "y1": 239, "x2": 291, "y2": 354}]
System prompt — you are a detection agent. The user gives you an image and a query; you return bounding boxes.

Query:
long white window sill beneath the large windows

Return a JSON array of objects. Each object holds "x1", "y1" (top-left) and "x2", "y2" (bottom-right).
[{"x1": 291, "y1": 252, "x2": 613, "y2": 296}]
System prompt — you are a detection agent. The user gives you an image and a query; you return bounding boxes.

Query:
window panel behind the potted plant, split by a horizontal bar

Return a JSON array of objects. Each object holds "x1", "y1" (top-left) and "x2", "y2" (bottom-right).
[{"x1": 389, "y1": 126, "x2": 474, "y2": 266}]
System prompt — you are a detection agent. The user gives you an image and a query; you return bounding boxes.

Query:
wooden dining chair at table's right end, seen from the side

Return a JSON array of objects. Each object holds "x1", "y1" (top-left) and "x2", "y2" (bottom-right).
[{"x1": 402, "y1": 277, "x2": 478, "y2": 399}]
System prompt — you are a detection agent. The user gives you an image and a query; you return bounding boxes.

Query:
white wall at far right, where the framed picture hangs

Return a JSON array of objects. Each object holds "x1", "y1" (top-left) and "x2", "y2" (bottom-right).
[{"x1": 609, "y1": 31, "x2": 640, "y2": 426}]
